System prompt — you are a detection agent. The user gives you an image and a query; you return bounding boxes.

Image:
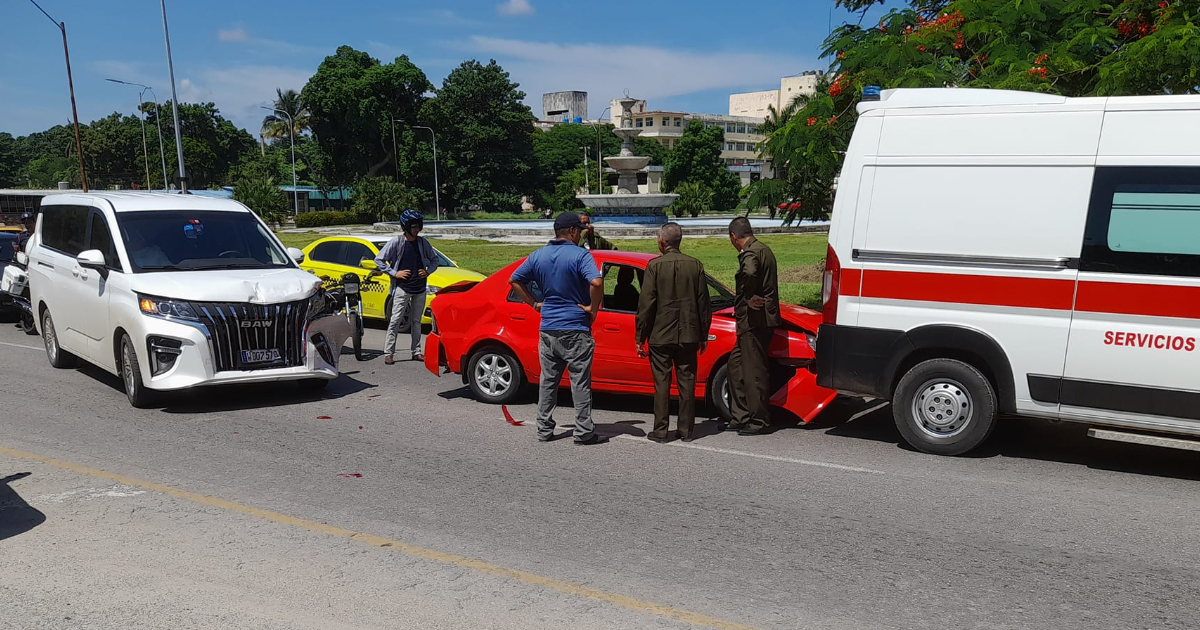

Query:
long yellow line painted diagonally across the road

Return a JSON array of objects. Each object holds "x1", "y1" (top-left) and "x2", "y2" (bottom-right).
[{"x1": 0, "y1": 446, "x2": 758, "y2": 630}]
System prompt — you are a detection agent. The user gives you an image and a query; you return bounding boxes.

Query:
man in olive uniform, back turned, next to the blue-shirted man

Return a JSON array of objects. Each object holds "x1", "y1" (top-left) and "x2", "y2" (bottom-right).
[{"x1": 635, "y1": 223, "x2": 713, "y2": 443}]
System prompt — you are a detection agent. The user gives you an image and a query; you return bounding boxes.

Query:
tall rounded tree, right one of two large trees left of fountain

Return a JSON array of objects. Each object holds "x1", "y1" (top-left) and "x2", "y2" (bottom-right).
[{"x1": 422, "y1": 60, "x2": 535, "y2": 211}]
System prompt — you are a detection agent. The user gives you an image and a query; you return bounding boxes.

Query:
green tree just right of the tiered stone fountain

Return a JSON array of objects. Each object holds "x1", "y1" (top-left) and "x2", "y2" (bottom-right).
[{"x1": 662, "y1": 120, "x2": 742, "y2": 211}]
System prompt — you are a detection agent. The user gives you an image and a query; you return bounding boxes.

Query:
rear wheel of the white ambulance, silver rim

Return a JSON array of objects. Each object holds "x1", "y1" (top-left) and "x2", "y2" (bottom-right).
[{"x1": 892, "y1": 359, "x2": 997, "y2": 455}]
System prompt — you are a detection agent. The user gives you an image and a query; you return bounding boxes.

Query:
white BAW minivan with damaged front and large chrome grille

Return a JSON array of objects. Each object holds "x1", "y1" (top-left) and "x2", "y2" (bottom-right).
[{"x1": 28, "y1": 192, "x2": 350, "y2": 407}]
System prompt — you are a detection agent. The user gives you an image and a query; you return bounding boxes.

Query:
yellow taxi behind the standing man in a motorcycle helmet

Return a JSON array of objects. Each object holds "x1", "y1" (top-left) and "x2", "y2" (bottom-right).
[{"x1": 300, "y1": 234, "x2": 485, "y2": 324}]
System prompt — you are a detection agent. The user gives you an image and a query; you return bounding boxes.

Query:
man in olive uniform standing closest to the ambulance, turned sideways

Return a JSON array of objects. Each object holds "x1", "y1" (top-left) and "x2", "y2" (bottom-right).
[{"x1": 726, "y1": 217, "x2": 779, "y2": 436}]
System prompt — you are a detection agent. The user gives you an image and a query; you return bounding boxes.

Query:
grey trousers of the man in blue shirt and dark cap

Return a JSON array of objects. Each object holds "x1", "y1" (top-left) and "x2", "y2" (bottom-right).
[{"x1": 538, "y1": 330, "x2": 595, "y2": 440}]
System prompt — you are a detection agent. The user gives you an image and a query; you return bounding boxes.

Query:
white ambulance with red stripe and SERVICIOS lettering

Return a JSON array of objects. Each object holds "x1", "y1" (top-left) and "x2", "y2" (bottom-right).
[{"x1": 817, "y1": 89, "x2": 1200, "y2": 455}]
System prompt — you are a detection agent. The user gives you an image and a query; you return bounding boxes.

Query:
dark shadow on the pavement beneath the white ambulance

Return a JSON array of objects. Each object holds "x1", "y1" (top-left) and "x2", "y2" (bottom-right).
[{"x1": 805, "y1": 398, "x2": 1200, "y2": 481}]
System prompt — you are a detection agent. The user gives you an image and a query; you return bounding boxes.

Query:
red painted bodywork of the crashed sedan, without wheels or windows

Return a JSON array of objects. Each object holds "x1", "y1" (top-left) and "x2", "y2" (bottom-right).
[{"x1": 425, "y1": 251, "x2": 836, "y2": 422}]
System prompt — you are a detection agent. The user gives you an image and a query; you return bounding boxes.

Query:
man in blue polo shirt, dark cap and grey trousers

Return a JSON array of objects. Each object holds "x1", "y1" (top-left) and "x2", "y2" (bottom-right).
[{"x1": 509, "y1": 212, "x2": 608, "y2": 445}]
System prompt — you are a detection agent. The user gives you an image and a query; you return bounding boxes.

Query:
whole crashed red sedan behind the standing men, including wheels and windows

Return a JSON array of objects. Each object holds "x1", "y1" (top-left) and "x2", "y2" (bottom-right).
[{"x1": 425, "y1": 251, "x2": 836, "y2": 422}]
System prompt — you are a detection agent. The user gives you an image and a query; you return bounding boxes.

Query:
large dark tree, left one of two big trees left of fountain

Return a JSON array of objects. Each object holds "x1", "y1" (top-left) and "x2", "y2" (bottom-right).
[{"x1": 300, "y1": 46, "x2": 433, "y2": 184}]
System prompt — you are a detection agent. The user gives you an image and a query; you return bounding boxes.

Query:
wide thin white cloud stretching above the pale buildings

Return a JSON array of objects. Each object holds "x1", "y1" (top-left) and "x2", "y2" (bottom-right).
[{"x1": 463, "y1": 36, "x2": 815, "y2": 114}]
